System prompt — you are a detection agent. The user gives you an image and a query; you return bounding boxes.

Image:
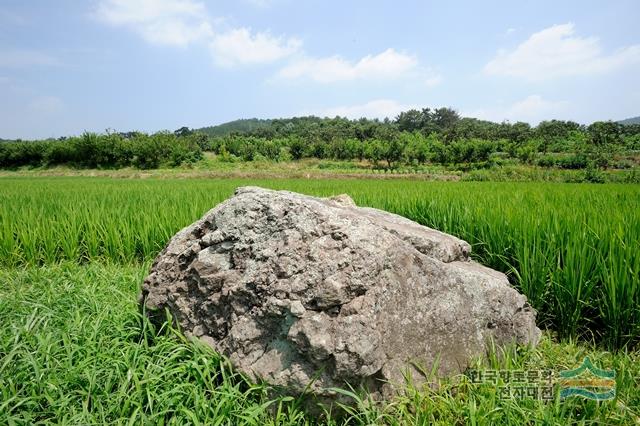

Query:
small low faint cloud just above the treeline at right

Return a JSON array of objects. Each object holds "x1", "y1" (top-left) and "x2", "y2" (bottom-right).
[{"x1": 461, "y1": 95, "x2": 569, "y2": 124}]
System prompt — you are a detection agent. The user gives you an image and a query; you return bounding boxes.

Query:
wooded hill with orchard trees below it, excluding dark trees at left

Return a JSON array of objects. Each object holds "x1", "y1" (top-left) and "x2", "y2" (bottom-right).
[{"x1": 210, "y1": 108, "x2": 640, "y2": 169}]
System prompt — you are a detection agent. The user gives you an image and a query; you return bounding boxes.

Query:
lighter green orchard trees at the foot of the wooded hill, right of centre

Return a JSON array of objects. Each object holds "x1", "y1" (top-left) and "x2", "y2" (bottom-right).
[{"x1": 211, "y1": 132, "x2": 640, "y2": 169}]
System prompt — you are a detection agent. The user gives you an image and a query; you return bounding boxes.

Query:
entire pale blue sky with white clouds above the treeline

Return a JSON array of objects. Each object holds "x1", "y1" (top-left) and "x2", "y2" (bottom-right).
[{"x1": 0, "y1": 0, "x2": 640, "y2": 138}]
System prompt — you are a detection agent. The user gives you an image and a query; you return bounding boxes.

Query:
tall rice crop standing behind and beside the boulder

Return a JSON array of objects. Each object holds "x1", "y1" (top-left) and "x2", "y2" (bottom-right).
[{"x1": 0, "y1": 178, "x2": 640, "y2": 348}]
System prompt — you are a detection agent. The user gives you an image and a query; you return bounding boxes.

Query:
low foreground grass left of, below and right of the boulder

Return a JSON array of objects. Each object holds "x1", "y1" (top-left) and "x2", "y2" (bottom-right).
[{"x1": 0, "y1": 263, "x2": 640, "y2": 426}]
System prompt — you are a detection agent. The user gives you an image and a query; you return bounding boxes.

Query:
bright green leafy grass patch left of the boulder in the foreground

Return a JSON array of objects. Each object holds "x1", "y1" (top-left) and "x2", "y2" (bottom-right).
[{"x1": 0, "y1": 265, "x2": 302, "y2": 425}]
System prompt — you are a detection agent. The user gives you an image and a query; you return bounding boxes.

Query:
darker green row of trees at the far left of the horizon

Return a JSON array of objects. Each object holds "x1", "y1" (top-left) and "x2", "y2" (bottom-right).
[{"x1": 0, "y1": 131, "x2": 208, "y2": 169}]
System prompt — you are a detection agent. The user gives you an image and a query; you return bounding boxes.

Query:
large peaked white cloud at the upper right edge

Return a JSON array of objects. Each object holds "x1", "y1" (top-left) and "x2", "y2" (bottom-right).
[{"x1": 484, "y1": 23, "x2": 640, "y2": 80}]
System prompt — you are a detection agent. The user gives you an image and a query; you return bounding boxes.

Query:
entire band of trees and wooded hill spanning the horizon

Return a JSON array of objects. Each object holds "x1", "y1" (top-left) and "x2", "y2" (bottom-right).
[{"x1": 0, "y1": 108, "x2": 640, "y2": 169}]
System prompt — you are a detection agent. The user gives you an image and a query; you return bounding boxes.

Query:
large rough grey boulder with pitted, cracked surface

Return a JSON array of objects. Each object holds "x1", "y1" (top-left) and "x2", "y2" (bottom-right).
[{"x1": 141, "y1": 187, "x2": 540, "y2": 402}]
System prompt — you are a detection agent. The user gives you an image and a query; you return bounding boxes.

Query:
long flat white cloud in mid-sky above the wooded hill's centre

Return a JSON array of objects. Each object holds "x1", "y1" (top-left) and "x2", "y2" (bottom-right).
[{"x1": 278, "y1": 49, "x2": 420, "y2": 83}]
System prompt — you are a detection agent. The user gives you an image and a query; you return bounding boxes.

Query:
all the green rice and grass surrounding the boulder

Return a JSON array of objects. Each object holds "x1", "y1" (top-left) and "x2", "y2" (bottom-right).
[{"x1": 0, "y1": 177, "x2": 640, "y2": 424}]
